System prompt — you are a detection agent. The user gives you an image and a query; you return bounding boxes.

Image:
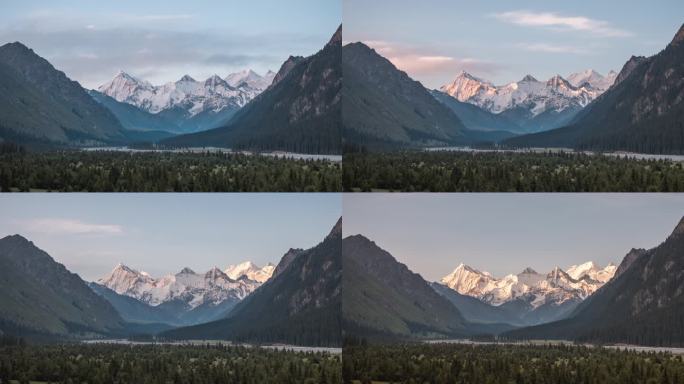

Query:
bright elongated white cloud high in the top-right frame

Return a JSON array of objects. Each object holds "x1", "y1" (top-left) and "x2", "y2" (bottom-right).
[{"x1": 492, "y1": 10, "x2": 632, "y2": 37}]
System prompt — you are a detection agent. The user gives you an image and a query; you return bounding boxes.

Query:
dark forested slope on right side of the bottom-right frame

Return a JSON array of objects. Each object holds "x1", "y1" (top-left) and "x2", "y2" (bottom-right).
[{"x1": 506, "y1": 219, "x2": 684, "y2": 347}]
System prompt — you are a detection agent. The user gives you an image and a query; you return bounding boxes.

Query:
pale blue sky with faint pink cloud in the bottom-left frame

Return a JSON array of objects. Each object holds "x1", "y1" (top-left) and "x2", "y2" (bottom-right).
[{"x1": 0, "y1": 193, "x2": 342, "y2": 281}]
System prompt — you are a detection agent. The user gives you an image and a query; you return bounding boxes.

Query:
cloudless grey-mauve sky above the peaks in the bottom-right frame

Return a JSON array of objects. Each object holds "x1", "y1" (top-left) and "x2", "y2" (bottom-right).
[{"x1": 343, "y1": 193, "x2": 684, "y2": 281}]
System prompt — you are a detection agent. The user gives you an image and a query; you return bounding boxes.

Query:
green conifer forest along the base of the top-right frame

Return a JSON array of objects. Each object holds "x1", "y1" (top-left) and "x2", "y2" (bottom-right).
[{"x1": 342, "y1": 151, "x2": 684, "y2": 192}]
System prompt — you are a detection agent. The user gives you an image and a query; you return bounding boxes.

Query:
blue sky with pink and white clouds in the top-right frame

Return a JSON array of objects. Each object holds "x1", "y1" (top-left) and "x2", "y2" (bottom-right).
[{"x1": 342, "y1": 0, "x2": 684, "y2": 88}]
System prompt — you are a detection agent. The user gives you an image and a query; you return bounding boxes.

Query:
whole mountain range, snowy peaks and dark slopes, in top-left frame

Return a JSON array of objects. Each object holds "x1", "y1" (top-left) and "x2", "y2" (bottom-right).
[{"x1": 0, "y1": 26, "x2": 342, "y2": 154}]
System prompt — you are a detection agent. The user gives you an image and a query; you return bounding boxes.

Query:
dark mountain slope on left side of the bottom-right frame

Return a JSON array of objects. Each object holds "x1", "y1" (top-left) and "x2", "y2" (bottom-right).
[{"x1": 342, "y1": 235, "x2": 470, "y2": 338}]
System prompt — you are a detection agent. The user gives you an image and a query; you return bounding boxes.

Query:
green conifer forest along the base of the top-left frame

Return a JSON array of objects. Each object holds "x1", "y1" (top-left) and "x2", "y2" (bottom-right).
[{"x1": 0, "y1": 146, "x2": 342, "y2": 192}]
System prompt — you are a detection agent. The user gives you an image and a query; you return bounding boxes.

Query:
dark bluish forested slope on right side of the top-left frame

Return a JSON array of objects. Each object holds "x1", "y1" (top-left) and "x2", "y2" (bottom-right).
[{"x1": 164, "y1": 26, "x2": 342, "y2": 153}]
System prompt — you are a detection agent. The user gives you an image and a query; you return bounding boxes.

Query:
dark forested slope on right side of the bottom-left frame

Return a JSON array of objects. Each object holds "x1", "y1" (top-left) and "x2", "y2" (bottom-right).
[{"x1": 162, "y1": 219, "x2": 342, "y2": 346}]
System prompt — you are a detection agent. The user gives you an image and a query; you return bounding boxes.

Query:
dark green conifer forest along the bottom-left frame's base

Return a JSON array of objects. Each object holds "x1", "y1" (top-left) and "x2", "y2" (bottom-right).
[{"x1": 0, "y1": 343, "x2": 342, "y2": 384}]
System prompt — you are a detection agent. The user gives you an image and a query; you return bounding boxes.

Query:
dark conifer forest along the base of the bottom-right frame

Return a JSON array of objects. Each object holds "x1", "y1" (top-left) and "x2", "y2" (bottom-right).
[{"x1": 343, "y1": 344, "x2": 684, "y2": 384}]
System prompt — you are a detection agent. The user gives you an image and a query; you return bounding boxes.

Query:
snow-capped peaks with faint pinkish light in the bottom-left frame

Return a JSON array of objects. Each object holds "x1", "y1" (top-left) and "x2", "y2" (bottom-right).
[{"x1": 97, "y1": 263, "x2": 267, "y2": 309}]
